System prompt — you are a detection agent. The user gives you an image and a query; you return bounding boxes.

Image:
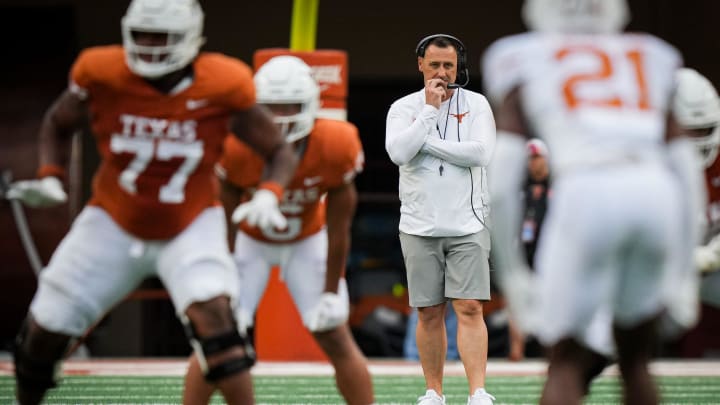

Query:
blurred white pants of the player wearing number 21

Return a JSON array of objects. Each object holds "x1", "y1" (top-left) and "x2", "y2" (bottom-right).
[{"x1": 537, "y1": 162, "x2": 689, "y2": 353}]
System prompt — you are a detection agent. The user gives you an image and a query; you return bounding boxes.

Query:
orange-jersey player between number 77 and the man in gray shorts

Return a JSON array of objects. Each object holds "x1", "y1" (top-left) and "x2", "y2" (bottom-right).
[{"x1": 184, "y1": 56, "x2": 374, "y2": 405}]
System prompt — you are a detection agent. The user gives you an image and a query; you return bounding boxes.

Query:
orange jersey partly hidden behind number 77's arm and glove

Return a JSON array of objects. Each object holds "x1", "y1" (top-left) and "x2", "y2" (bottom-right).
[{"x1": 220, "y1": 119, "x2": 364, "y2": 243}]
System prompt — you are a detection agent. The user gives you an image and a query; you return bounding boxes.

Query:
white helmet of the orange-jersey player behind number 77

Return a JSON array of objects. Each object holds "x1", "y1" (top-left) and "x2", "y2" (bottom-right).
[{"x1": 255, "y1": 55, "x2": 320, "y2": 143}]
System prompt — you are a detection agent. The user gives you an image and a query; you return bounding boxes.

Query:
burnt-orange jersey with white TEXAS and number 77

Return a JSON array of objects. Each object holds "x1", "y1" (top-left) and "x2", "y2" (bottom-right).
[{"x1": 70, "y1": 46, "x2": 255, "y2": 239}]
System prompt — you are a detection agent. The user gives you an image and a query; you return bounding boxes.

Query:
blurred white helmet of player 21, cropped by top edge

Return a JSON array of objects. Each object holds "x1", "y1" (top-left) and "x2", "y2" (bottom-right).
[{"x1": 522, "y1": 0, "x2": 630, "y2": 34}]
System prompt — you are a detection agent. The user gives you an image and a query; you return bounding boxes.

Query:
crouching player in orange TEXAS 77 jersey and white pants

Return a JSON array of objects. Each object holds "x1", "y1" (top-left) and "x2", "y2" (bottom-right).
[{"x1": 3, "y1": 0, "x2": 297, "y2": 405}]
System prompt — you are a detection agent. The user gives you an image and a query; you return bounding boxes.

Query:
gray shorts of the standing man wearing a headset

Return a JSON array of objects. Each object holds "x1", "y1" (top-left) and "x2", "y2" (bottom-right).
[{"x1": 400, "y1": 229, "x2": 490, "y2": 307}]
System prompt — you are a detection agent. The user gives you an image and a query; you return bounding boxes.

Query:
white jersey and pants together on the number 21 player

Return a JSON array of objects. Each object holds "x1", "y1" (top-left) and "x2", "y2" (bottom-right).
[{"x1": 484, "y1": 33, "x2": 690, "y2": 348}]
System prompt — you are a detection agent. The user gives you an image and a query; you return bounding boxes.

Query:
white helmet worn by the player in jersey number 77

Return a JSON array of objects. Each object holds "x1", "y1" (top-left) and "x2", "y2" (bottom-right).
[{"x1": 122, "y1": 0, "x2": 205, "y2": 79}]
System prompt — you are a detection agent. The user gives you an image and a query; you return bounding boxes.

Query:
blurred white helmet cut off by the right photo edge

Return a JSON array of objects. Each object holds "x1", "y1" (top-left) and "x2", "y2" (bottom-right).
[{"x1": 673, "y1": 68, "x2": 720, "y2": 167}]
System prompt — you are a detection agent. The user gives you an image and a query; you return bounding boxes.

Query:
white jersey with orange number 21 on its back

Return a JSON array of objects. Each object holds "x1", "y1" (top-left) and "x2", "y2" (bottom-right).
[{"x1": 483, "y1": 32, "x2": 682, "y2": 172}]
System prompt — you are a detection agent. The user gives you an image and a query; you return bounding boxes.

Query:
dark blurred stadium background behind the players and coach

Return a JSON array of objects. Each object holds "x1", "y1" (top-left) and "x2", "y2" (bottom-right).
[{"x1": 0, "y1": 0, "x2": 720, "y2": 372}]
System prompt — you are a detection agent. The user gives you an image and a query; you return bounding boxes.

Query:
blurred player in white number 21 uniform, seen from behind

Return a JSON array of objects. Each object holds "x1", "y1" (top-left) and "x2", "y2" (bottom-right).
[{"x1": 483, "y1": 0, "x2": 702, "y2": 404}]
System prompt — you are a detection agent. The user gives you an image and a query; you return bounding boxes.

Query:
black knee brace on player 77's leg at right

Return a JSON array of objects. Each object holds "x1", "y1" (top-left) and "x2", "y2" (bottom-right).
[{"x1": 183, "y1": 317, "x2": 255, "y2": 383}]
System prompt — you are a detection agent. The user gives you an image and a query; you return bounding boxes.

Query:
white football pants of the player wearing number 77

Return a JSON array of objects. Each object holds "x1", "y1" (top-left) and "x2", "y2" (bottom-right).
[{"x1": 30, "y1": 206, "x2": 237, "y2": 336}]
